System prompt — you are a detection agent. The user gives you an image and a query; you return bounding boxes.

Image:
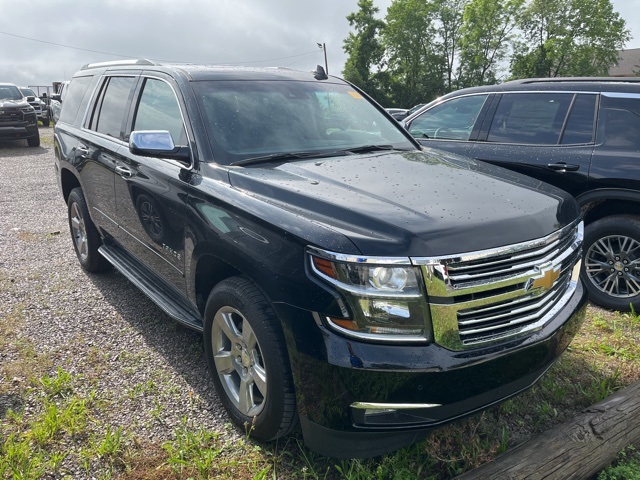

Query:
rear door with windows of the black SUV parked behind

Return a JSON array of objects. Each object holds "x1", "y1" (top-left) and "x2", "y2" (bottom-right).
[{"x1": 469, "y1": 92, "x2": 598, "y2": 196}]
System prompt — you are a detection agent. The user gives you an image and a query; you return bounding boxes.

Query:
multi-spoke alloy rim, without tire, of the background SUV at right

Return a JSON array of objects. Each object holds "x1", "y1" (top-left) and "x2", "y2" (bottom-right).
[{"x1": 585, "y1": 235, "x2": 640, "y2": 298}]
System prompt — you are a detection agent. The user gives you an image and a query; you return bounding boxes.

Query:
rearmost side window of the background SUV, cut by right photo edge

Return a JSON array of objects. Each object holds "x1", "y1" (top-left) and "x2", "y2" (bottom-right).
[{"x1": 598, "y1": 95, "x2": 640, "y2": 150}]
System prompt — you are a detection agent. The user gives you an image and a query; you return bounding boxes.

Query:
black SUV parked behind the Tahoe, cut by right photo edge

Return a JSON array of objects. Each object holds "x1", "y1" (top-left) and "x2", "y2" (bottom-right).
[{"x1": 404, "y1": 78, "x2": 640, "y2": 310}]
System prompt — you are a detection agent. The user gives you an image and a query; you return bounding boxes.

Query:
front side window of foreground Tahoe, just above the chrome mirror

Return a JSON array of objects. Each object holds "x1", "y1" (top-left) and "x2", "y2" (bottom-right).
[{"x1": 133, "y1": 78, "x2": 187, "y2": 145}]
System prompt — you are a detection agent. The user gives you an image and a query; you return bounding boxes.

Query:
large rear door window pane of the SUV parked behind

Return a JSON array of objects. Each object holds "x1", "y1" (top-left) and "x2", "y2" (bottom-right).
[{"x1": 487, "y1": 93, "x2": 573, "y2": 145}]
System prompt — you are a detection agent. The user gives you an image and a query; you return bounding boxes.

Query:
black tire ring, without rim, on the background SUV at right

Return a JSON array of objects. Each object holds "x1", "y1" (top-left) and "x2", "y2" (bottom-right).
[{"x1": 580, "y1": 216, "x2": 640, "y2": 311}]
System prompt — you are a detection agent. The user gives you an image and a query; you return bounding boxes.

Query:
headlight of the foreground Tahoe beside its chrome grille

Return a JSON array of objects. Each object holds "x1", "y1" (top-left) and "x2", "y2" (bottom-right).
[{"x1": 309, "y1": 249, "x2": 431, "y2": 342}]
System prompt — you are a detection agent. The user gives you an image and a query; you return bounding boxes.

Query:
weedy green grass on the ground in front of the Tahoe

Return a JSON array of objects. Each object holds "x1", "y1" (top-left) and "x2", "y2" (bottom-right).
[{"x1": 0, "y1": 305, "x2": 640, "y2": 480}]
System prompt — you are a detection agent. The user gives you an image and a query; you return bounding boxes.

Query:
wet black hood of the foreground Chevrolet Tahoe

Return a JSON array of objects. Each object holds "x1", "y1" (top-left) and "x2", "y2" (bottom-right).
[{"x1": 229, "y1": 150, "x2": 579, "y2": 256}]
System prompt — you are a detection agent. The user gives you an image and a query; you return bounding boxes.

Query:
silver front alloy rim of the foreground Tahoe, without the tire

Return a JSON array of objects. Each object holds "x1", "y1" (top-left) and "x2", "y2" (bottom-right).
[{"x1": 211, "y1": 307, "x2": 267, "y2": 417}]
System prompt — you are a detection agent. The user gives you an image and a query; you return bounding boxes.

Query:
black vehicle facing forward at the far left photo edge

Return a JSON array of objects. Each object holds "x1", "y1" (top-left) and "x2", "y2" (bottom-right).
[{"x1": 0, "y1": 83, "x2": 40, "y2": 147}]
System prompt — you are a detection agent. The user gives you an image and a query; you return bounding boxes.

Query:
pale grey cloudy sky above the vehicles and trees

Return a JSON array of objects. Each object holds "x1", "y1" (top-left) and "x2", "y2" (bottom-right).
[{"x1": 0, "y1": 0, "x2": 640, "y2": 89}]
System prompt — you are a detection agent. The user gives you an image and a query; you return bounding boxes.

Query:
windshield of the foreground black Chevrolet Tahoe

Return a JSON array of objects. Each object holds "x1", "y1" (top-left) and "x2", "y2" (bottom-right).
[{"x1": 194, "y1": 81, "x2": 416, "y2": 165}]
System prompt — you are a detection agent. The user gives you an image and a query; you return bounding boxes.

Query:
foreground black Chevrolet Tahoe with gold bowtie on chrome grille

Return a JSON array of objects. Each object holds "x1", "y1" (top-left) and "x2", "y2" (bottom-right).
[{"x1": 54, "y1": 60, "x2": 586, "y2": 457}]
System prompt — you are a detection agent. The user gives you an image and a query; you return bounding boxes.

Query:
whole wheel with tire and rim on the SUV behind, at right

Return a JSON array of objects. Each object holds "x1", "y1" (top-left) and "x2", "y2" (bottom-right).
[{"x1": 581, "y1": 215, "x2": 640, "y2": 311}]
